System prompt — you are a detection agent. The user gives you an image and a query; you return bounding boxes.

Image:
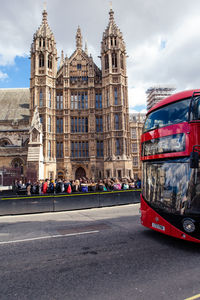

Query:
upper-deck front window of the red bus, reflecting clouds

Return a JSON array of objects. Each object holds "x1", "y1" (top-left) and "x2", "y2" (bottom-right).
[{"x1": 144, "y1": 98, "x2": 191, "y2": 132}]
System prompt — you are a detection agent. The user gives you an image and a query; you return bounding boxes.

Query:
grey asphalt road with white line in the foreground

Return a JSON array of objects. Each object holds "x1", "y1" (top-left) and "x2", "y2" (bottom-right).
[{"x1": 0, "y1": 204, "x2": 200, "y2": 300}]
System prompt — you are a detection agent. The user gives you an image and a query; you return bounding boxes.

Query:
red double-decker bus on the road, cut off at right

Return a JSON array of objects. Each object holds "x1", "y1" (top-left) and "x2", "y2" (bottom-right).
[{"x1": 141, "y1": 90, "x2": 200, "y2": 242}]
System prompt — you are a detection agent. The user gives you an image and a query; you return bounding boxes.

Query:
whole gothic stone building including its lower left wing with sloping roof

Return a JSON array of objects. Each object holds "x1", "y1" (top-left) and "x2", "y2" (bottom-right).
[{"x1": 0, "y1": 9, "x2": 133, "y2": 179}]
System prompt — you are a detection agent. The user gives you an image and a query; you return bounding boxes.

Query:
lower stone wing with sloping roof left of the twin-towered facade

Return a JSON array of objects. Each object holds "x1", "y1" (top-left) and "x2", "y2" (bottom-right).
[{"x1": 0, "y1": 89, "x2": 30, "y2": 185}]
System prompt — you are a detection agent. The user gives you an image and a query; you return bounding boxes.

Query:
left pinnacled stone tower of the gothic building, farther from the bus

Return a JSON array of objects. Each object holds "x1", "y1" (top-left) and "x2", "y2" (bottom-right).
[{"x1": 30, "y1": 10, "x2": 57, "y2": 178}]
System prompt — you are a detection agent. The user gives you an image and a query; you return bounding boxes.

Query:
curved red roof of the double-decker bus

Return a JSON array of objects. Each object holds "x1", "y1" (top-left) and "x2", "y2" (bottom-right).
[{"x1": 147, "y1": 89, "x2": 200, "y2": 115}]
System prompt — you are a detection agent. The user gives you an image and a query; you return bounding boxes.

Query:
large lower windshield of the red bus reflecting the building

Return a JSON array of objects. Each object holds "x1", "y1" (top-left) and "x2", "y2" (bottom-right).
[{"x1": 142, "y1": 158, "x2": 200, "y2": 215}]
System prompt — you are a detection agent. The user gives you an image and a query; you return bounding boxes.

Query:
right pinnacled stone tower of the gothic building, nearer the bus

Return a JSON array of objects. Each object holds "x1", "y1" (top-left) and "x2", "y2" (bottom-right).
[{"x1": 101, "y1": 8, "x2": 132, "y2": 178}]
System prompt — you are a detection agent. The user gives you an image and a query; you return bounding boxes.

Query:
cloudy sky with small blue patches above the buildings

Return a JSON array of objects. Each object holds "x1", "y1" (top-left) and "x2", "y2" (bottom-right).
[{"x1": 0, "y1": 0, "x2": 200, "y2": 111}]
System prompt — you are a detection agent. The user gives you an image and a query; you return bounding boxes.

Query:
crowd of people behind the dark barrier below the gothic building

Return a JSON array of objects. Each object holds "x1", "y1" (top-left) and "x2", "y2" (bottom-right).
[{"x1": 13, "y1": 178, "x2": 141, "y2": 196}]
